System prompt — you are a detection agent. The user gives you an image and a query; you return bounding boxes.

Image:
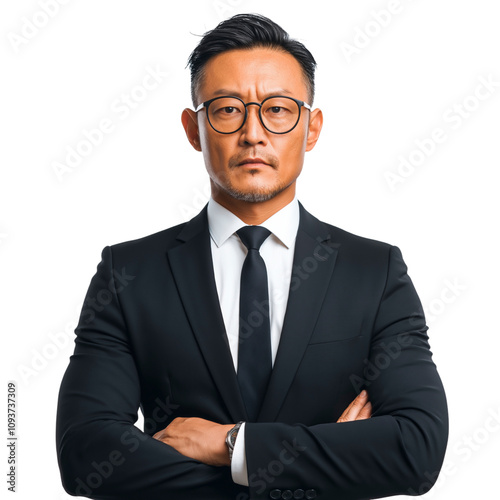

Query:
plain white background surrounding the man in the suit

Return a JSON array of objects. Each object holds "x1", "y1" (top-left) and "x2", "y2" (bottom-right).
[{"x1": 0, "y1": 0, "x2": 500, "y2": 500}]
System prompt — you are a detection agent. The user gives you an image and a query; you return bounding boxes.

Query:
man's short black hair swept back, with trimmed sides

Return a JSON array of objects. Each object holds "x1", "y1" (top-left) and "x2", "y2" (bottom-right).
[{"x1": 188, "y1": 14, "x2": 316, "y2": 106}]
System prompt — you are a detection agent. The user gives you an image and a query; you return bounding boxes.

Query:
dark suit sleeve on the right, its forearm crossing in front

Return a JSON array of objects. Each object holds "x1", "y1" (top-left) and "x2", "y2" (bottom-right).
[{"x1": 245, "y1": 247, "x2": 448, "y2": 500}]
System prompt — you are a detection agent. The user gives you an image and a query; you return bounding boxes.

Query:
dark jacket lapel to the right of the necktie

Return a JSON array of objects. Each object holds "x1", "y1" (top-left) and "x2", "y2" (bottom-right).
[{"x1": 258, "y1": 204, "x2": 338, "y2": 422}]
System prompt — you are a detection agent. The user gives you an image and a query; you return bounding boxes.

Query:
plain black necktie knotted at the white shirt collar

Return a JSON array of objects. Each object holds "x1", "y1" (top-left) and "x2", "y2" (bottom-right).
[{"x1": 236, "y1": 226, "x2": 272, "y2": 421}]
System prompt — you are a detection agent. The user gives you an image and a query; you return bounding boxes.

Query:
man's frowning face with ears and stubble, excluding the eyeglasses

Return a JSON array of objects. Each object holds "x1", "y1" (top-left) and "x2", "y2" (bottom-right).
[{"x1": 183, "y1": 48, "x2": 322, "y2": 202}]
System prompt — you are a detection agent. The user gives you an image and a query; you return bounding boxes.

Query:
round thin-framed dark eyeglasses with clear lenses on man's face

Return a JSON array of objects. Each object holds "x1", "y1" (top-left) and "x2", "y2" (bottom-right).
[{"x1": 195, "y1": 95, "x2": 311, "y2": 134}]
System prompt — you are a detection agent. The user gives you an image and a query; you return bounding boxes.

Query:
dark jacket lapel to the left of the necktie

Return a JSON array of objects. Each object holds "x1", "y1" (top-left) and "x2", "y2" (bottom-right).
[{"x1": 167, "y1": 206, "x2": 247, "y2": 422}]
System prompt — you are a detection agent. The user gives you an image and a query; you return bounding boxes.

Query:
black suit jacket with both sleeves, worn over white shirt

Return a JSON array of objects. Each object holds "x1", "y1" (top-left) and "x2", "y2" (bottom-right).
[{"x1": 57, "y1": 205, "x2": 448, "y2": 500}]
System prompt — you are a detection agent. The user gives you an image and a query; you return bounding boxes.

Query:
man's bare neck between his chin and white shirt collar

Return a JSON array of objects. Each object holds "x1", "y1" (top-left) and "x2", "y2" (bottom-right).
[{"x1": 212, "y1": 183, "x2": 295, "y2": 226}]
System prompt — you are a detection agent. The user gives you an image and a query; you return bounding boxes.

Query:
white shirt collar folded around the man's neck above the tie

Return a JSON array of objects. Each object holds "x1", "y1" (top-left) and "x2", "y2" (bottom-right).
[{"x1": 207, "y1": 197, "x2": 300, "y2": 248}]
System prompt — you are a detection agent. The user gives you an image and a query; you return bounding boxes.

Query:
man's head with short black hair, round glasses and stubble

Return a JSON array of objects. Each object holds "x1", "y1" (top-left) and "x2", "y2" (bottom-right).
[{"x1": 182, "y1": 15, "x2": 322, "y2": 208}]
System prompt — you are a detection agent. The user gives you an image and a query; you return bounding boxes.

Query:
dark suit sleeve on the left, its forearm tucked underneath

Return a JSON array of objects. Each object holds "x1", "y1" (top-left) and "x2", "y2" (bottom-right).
[{"x1": 56, "y1": 247, "x2": 241, "y2": 500}]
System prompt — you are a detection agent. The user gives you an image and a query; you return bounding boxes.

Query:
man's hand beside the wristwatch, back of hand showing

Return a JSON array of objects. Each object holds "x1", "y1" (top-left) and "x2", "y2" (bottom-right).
[{"x1": 153, "y1": 417, "x2": 234, "y2": 467}]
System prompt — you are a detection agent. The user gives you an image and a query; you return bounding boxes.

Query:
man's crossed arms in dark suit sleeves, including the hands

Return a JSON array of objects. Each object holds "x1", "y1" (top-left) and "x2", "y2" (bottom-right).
[{"x1": 57, "y1": 244, "x2": 448, "y2": 500}]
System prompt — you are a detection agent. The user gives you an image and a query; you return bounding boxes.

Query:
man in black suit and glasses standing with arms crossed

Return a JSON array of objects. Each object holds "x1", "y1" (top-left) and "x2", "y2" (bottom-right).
[{"x1": 57, "y1": 15, "x2": 448, "y2": 500}]
